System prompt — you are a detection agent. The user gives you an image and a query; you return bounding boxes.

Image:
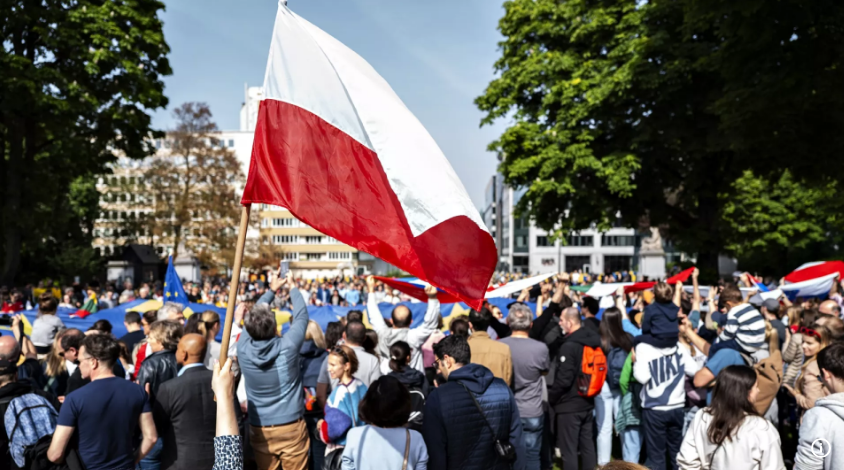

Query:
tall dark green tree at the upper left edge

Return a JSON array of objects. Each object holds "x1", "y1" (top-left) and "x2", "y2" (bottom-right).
[{"x1": 0, "y1": 0, "x2": 171, "y2": 284}]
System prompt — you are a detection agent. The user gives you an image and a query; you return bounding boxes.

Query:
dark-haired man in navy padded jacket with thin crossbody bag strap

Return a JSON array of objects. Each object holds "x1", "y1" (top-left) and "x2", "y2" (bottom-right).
[{"x1": 422, "y1": 336, "x2": 525, "y2": 470}]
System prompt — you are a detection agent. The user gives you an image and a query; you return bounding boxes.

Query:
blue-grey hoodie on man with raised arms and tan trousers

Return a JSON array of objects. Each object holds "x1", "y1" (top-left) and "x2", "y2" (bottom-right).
[{"x1": 237, "y1": 289, "x2": 308, "y2": 426}]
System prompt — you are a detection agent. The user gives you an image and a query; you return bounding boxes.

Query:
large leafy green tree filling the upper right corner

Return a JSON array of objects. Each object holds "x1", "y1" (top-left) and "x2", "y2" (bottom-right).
[{"x1": 476, "y1": 0, "x2": 844, "y2": 276}]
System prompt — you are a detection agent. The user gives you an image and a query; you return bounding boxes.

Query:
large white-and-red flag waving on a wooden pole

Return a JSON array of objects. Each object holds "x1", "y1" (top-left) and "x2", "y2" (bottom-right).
[{"x1": 241, "y1": 2, "x2": 497, "y2": 307}]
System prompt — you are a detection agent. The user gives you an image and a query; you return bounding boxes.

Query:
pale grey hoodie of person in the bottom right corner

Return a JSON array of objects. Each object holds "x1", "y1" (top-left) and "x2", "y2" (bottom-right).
[{"x1": 794, "y1": 393, "x2": 844, "y2": 470}]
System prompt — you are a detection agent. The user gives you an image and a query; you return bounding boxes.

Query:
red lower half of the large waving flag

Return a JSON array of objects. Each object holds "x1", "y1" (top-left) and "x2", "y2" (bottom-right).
[{"x1": 241, "y1": 99, "x2": 497, "y2": 308}]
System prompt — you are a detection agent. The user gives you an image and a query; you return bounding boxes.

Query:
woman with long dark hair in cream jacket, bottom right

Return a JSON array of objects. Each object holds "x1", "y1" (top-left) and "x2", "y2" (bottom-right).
[{"x1": 677, "y1": 366, "x2": 785, "y2": 470}]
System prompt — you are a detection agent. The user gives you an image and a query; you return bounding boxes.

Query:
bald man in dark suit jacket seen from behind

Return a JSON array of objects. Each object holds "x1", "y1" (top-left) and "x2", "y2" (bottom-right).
[{"x1": 153, "y1": 334, "x2": 217, "y2": 470}]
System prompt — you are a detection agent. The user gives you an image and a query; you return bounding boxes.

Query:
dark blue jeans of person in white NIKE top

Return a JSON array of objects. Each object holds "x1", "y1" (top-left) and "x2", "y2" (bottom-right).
[{"x1": 642, "y1": 407, "x2": 684, "y2": 470}]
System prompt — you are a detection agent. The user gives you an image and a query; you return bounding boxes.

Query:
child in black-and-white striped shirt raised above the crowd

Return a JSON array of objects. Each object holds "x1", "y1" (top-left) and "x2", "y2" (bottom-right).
[{"x1": 709, "y1": 284, "x2": 765, "y2": 357}]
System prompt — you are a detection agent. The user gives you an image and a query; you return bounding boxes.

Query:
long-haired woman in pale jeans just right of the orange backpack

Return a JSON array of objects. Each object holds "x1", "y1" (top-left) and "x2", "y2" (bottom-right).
[{"x1": 595, "y1": 307, "x2": 638, "y2": 465}]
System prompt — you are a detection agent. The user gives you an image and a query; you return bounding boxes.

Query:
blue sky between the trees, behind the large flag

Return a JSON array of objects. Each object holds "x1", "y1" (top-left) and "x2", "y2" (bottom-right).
[{"x1": 153, "y1": 0, "x2": 505, "y2": 207}]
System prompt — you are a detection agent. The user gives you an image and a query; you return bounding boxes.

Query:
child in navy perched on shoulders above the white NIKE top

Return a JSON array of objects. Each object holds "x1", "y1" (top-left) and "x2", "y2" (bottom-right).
[{"x1": 634, "y1": 281, "x2": 683, "y2": 348}]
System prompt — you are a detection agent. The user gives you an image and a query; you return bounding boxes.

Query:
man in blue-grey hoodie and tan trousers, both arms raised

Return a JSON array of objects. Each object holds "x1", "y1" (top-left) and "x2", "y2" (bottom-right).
[{"x1": 237, "y1": 273, "x2": 309, "y2": 470}]
